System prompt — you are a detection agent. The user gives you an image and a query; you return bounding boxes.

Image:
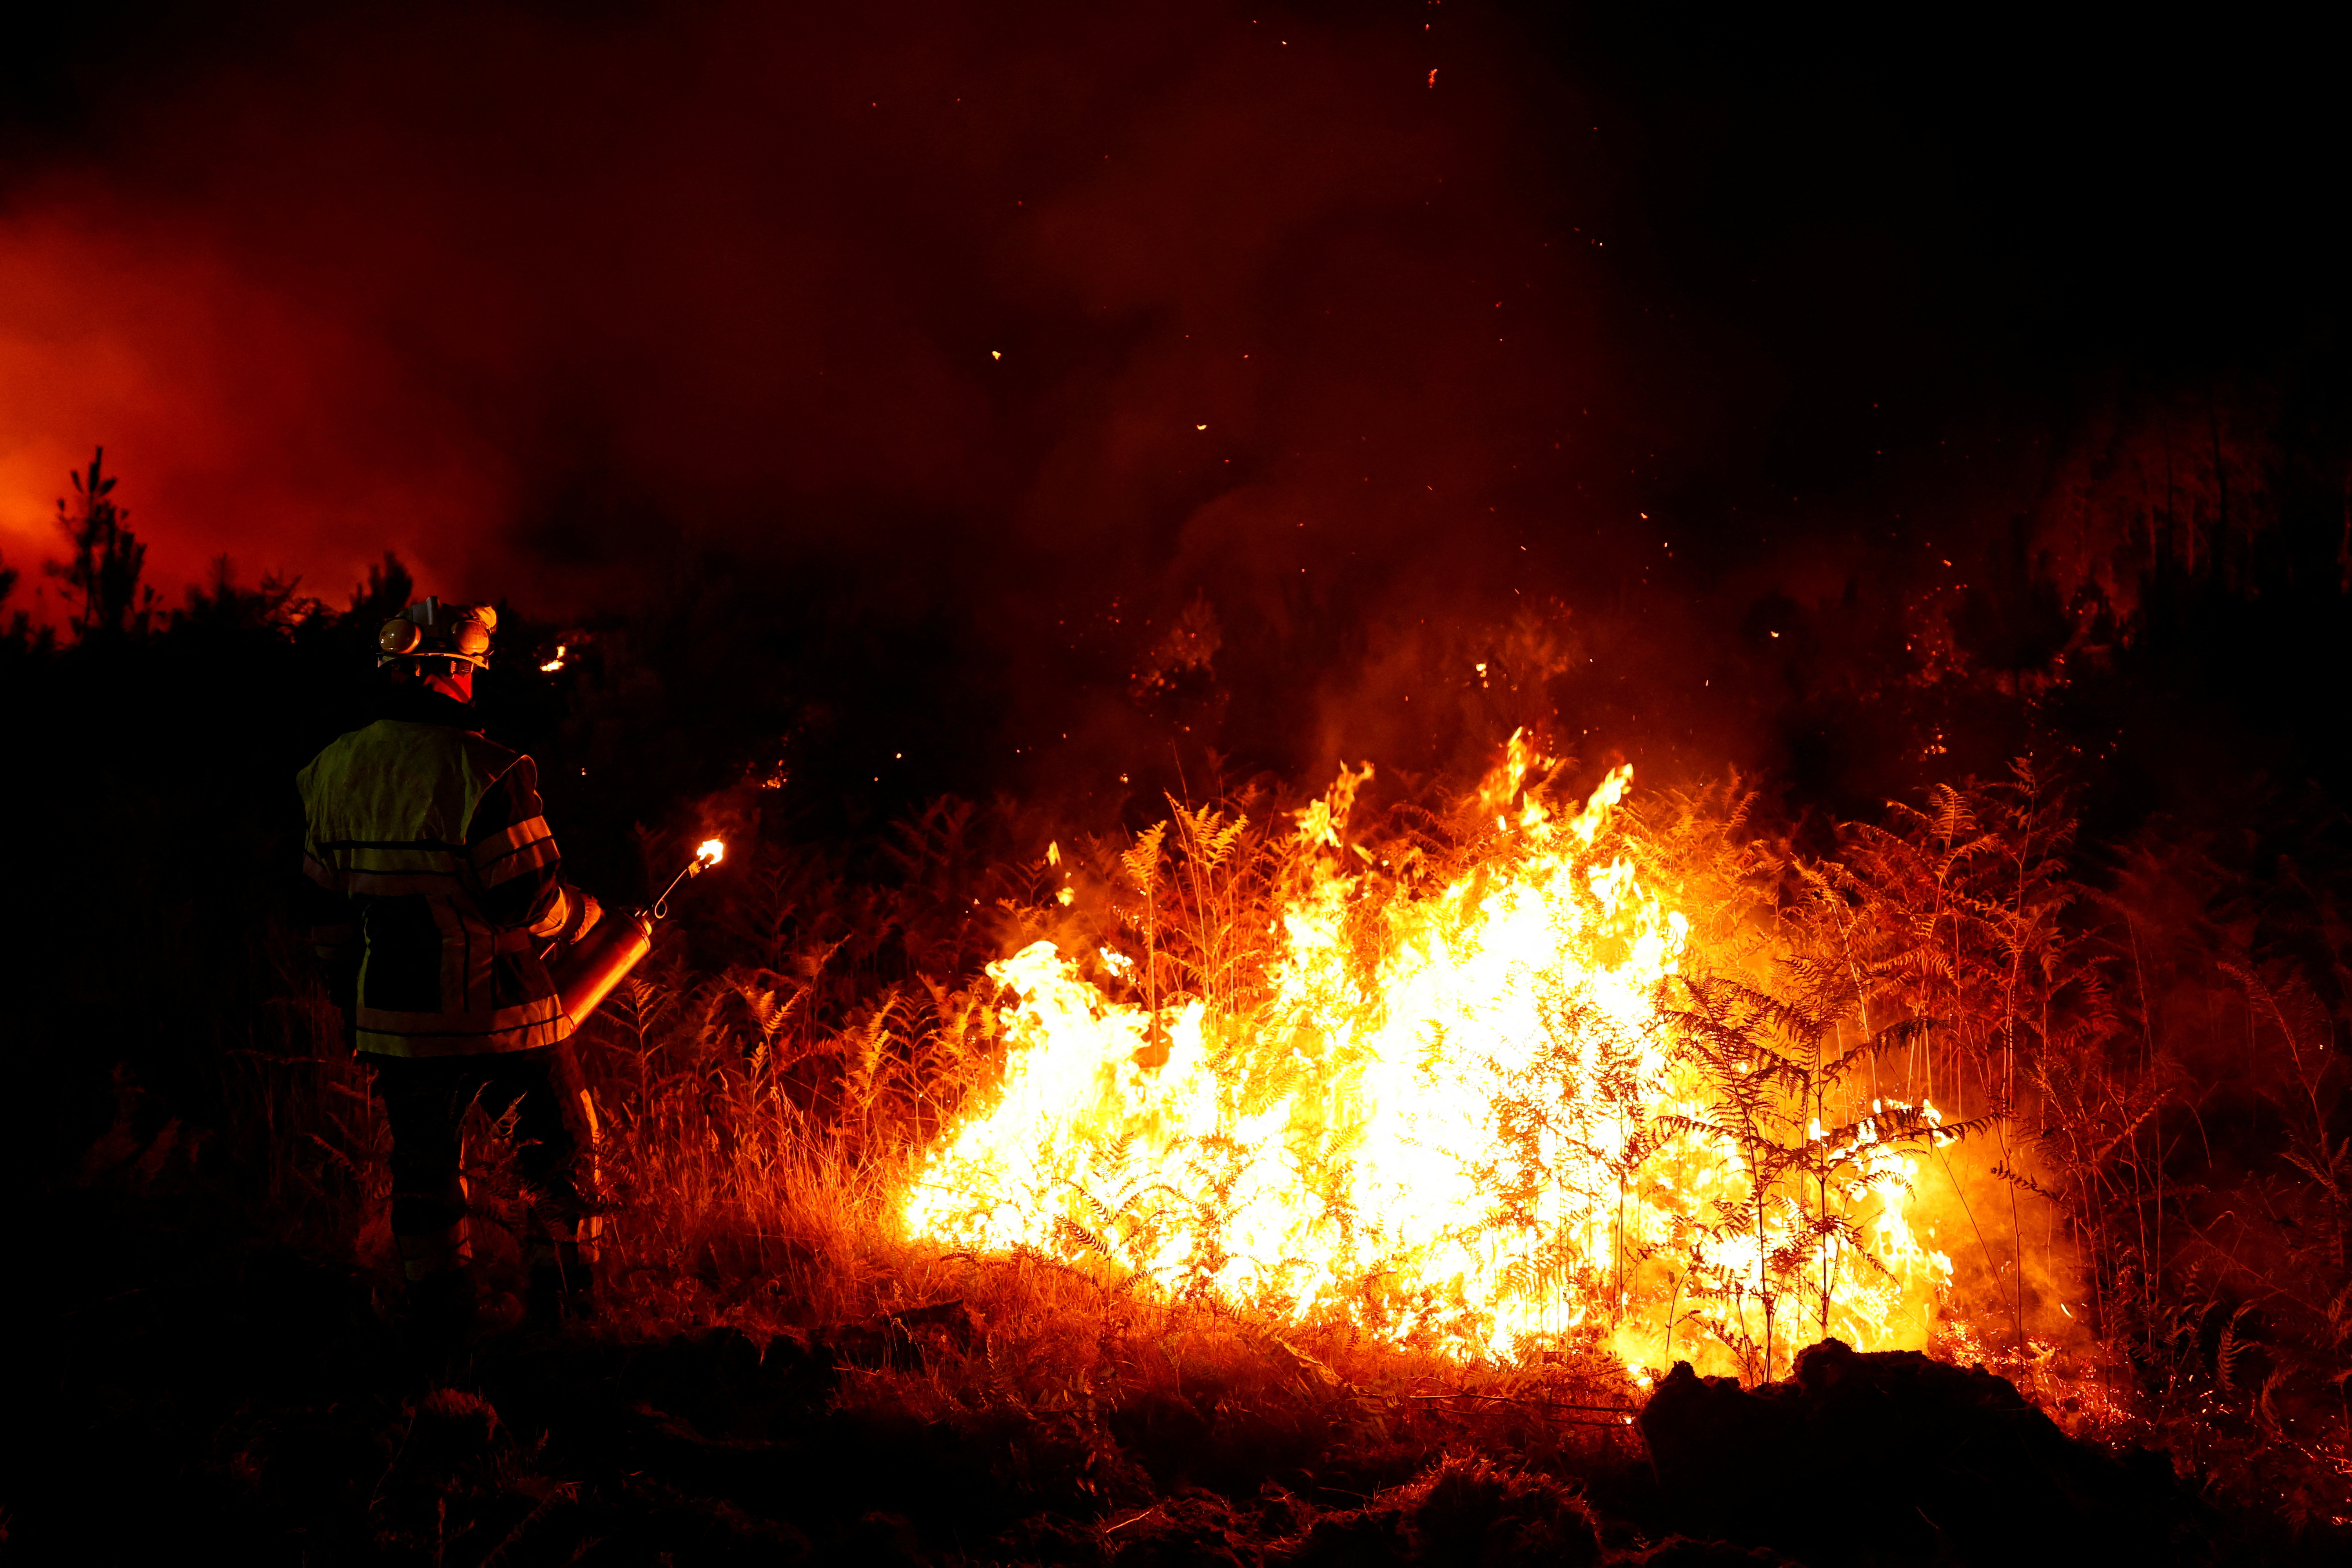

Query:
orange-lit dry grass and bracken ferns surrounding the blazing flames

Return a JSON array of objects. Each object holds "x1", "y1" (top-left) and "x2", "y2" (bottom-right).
[{"x1": 230, "y1": 769, "x2": 2352, "y2": 1514}]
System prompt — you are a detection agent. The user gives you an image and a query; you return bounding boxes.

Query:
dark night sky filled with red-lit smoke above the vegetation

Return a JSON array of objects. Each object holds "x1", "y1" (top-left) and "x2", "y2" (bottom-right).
[{"x1": 0, "y1": 2, "x2": 2345, "y2": 792}]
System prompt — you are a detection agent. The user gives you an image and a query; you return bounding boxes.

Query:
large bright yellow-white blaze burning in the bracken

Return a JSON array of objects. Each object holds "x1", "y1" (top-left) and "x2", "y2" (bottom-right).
[{"x1": 903, "y1": 738, "x2": 1952, "y2": 1370}]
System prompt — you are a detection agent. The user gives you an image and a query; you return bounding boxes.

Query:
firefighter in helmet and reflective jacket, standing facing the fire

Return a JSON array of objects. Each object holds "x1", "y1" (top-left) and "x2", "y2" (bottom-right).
[{"x1": 296, "y1": 599, "x2": 600, "y2": 1340}]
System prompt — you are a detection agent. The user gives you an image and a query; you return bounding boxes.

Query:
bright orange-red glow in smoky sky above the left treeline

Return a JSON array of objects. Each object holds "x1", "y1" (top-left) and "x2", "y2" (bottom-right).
[{"x1": 0, "y1": 202, "x2": 506, "y2": 618}]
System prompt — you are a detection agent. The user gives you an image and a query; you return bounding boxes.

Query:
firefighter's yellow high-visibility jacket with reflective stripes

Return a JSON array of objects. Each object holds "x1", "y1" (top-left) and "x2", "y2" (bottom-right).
[{"x1": 296, "y1": 703, "x2": 586, "y2": 1056}]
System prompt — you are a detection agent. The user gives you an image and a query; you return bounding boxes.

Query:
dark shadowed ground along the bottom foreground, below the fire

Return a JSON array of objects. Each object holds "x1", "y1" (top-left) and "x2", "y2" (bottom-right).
[{"x1": 0, "y1": 1189, "x2": 2345, "y2": 1568}]
